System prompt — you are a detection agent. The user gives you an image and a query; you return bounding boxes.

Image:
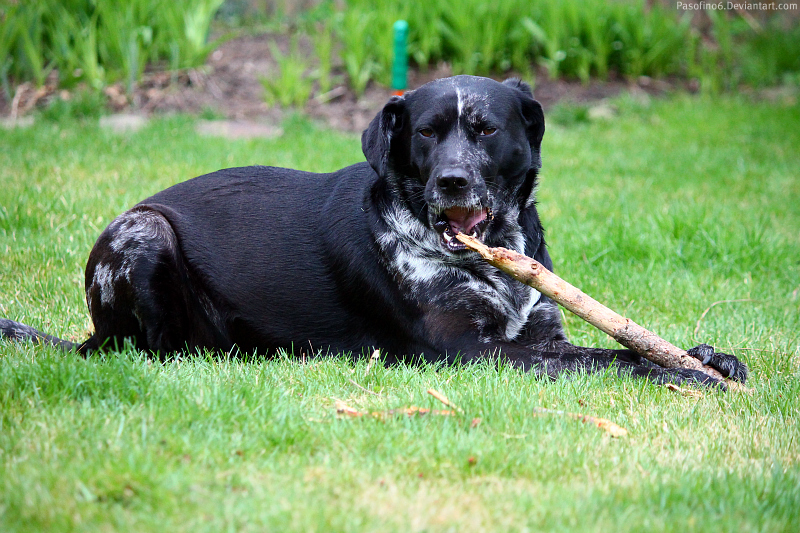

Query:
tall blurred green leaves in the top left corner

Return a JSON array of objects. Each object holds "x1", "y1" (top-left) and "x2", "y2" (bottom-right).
[{"x1": 0, "y1": 0, "x2": 223, "y2": 90}]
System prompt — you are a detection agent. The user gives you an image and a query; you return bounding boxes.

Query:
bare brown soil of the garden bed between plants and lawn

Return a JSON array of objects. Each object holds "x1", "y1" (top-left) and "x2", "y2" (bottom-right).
[{"x1": 0, "y1": 34, "x2": 686, "y2": 136}]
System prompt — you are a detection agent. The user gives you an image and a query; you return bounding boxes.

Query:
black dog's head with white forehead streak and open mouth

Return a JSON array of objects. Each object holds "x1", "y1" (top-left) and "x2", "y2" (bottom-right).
[{"x1": 361, "y1": 76, "x2": 544, "y2": 252}]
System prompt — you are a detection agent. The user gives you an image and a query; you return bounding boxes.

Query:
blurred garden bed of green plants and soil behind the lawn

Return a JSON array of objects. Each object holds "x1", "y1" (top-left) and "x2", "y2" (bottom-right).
[{"x1": 0, "y1": 0, "x2": 800, "y2": 130}]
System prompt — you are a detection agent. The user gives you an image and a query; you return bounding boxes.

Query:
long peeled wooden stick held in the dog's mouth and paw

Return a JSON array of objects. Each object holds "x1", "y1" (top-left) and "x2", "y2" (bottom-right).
[{"x1": 456, "y1": 233, "x2": 738, "y2": 387}]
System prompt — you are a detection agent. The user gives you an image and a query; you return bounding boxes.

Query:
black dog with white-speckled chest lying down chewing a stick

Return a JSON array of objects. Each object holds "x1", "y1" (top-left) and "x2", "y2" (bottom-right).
[{"x1": 0, "y1": 76, "x2": 747, "y2": 384}]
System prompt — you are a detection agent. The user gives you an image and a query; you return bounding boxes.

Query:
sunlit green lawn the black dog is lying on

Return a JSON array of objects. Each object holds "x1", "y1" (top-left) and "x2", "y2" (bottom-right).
[{"x1": 0, "y1": 97, "x2": 800, "y2": 532}]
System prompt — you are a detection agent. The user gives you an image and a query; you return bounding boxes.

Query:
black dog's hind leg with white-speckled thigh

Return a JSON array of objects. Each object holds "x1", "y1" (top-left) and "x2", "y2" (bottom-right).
[{"x1": 84, "y1": 207, "x2": 229, "y2": 355}]
